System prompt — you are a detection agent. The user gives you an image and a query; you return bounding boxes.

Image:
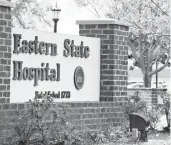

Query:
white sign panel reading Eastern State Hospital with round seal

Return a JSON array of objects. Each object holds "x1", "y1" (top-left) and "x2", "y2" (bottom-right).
[{"x1": 10, "y1": 29, "x2": 100, "y2": 102}]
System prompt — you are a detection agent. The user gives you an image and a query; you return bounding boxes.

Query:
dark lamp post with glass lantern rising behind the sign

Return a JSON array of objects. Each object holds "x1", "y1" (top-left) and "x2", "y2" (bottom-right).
[{"x1": 51, "y1": 4, "x2": 61, "y2": 33}]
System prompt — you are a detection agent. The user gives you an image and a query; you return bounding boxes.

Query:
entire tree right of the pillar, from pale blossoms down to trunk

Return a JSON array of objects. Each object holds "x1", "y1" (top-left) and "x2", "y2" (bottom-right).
[{"x1": 75, "y1": 0, "x2": 170, "y2": 87}]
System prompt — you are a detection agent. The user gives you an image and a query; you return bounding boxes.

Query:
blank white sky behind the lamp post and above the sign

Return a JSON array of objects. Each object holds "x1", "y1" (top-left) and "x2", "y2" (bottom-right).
[{"x1": 38, "y1": 0, "x2": 104, "y2": 35}]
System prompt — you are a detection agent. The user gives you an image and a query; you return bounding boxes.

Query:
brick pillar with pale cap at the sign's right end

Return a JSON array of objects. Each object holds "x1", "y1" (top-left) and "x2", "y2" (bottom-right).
[{"x1": 76, "y1": 19, "x2": 129, "y2": 101}]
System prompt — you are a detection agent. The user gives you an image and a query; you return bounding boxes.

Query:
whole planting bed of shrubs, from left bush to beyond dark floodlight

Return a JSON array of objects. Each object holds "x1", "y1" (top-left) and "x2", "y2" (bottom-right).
[{"x1": 3, "y1": 92, "x2": 170, "y2": 145}]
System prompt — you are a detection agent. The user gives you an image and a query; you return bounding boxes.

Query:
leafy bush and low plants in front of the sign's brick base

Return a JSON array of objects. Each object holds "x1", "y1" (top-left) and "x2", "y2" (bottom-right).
[{"x1": 3, "y1": 96, "x2": 130, "y2": 145}]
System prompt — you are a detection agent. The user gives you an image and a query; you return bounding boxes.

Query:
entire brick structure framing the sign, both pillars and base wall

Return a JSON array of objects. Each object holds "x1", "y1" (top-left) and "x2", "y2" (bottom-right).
[{"x1": 0, "y1": 1, "x2": 128, "y2": 143}]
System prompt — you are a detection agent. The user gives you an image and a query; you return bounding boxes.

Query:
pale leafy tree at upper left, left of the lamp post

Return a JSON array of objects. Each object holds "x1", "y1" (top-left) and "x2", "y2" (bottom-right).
[{"x1": 11, "y1": 0, "x2": 50, "y2": 29}]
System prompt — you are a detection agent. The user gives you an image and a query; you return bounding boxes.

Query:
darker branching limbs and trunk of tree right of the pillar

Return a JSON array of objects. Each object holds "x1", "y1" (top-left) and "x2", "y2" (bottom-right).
[{"x1": 128, "y1": 33, "x2": 170, "y2": 87}]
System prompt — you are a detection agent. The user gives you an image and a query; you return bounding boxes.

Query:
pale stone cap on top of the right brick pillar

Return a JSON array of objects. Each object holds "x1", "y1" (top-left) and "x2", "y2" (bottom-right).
[{"x1": 76, "y1": 19, "x2": 130, "y2": 27}]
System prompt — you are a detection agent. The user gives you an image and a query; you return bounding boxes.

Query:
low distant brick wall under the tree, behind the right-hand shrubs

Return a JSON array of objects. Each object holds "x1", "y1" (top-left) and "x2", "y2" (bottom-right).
[{"x1": 127, "y1": 88, "x2": 167, "y2": 104}]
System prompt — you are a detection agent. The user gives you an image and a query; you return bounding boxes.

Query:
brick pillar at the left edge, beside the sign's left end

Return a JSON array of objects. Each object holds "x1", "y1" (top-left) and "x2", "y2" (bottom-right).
[{"x1": 0, "y1": 0, "x2": 13, "y2": 104}]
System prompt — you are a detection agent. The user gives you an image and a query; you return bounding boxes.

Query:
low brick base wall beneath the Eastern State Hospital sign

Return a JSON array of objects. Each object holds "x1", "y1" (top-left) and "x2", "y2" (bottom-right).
[{"x1": 0, "y1": 102, "x2": 124, "y2": 144}]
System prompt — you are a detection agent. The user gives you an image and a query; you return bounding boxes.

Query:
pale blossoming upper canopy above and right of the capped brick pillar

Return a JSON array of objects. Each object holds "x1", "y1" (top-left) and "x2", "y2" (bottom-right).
[{"x1": 75, "y1": 0, "x2": 170, "y2": 34}]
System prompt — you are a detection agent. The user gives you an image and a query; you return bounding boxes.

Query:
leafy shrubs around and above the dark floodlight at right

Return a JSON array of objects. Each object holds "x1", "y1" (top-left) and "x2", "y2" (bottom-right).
[{"x1": 123, "y1": 91, "x2": 170, "y2": 132}]
